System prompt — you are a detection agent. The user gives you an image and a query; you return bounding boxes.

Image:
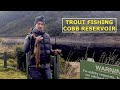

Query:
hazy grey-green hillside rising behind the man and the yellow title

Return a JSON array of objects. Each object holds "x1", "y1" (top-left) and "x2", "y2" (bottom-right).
[{"x1": 0, "y1": 11, "x2": 120, "y2": 36}]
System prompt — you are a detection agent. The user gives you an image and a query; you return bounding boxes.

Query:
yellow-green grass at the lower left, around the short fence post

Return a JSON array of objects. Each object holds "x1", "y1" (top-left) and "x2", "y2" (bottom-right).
[{"x1": 0, "y1": 59, "x2": 27, "y2": 79}]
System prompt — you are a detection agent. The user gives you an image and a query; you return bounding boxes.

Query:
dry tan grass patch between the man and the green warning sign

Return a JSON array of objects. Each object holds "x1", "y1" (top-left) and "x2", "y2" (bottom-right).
[{"x1": 60, "y1": 58, "x2": 80, "y2": 79}]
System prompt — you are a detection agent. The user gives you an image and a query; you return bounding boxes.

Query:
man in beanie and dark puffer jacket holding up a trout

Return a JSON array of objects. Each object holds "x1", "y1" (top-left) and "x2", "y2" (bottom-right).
[{"x1": 24, "y1": 16, "x2": 58, "y2": 79}]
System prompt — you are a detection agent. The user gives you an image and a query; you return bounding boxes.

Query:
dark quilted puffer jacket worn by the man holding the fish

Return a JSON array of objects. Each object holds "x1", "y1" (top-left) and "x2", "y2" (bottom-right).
[{"x1": 23, "y1": 29, "x2": 53, "y2": 65}]
